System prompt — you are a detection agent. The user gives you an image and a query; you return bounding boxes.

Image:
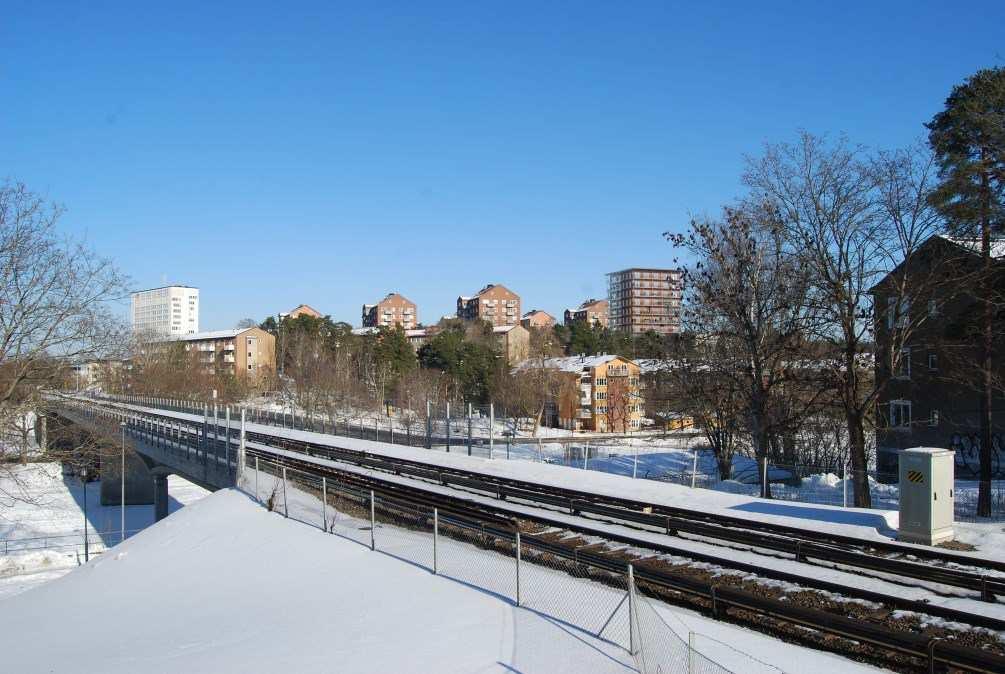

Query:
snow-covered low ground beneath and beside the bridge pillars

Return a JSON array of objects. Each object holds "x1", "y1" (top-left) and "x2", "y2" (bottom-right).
[{"x1": 0, "y1": 463, "x2": 207, "y2": 598}]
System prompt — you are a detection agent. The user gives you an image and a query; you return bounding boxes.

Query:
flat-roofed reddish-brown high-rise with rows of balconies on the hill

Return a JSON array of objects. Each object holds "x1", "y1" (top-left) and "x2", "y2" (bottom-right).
[{"x1": 607, "y1": 268, "x2": 683, "y2": 334}]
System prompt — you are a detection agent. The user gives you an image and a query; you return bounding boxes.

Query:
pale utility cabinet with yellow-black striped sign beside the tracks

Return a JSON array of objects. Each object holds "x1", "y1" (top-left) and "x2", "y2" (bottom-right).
[{"x1": 896, "y1": 447, "x2": 955, "y2": 545}]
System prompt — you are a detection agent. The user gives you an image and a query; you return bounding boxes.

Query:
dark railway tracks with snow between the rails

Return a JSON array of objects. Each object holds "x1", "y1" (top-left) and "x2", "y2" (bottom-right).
[{"x1": 57, "y1": 397, "x2": 1005, "y2": 672}]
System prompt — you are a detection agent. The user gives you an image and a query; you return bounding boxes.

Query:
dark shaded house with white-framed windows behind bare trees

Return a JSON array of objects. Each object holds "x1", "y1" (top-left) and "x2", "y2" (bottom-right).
[{"x1": 871, "y1": 235, "x2": 1005, "y2": 479}]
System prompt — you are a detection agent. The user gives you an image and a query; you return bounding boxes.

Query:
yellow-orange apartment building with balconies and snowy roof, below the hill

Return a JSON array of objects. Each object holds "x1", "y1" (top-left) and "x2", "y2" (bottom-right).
[{"x1": 521, "y1": 355, "x2": 644, "y2": 433}]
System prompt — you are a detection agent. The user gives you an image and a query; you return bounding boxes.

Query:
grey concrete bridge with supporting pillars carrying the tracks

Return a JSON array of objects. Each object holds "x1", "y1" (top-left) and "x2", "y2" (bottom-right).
[{"x1": 47, "y1": 396, "x2": 244, "y2": 520}]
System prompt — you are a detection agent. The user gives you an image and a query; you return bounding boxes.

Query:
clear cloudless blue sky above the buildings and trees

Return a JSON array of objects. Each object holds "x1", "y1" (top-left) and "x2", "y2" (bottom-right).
[{"x1": 0, "y1": 0, "x2": 1005, "y2": 329}]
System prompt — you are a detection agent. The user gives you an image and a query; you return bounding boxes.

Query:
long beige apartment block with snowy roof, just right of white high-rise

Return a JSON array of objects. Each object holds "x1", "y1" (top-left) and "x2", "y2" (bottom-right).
[{"x1": 173, "y1": 327, "x2": 275, "y2": 383}]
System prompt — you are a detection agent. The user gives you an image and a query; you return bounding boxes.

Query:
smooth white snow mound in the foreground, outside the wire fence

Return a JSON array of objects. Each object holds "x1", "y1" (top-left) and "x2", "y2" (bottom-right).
[{"x1": 0, "y1": 490, "x2": 874, "y2": 674}]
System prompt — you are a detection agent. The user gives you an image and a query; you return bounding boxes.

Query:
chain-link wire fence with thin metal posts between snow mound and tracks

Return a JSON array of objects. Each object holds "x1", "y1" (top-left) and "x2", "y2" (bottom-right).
[{"x1": 237, "y1": 455, "x2": 753, "y2": 674}]
